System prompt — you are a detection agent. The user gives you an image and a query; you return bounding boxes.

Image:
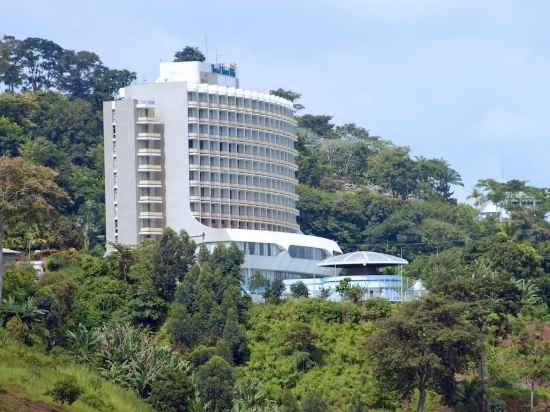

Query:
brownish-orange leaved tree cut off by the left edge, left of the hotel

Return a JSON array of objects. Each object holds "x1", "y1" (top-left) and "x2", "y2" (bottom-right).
[{"x1": 0, "y1": 156, "x2": 67, "y2": 301}]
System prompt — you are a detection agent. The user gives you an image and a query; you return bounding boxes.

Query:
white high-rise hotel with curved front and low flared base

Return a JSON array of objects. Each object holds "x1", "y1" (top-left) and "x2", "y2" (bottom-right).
[{"x1": 103, "y1": 62, "x2": 341, "y2": 286}]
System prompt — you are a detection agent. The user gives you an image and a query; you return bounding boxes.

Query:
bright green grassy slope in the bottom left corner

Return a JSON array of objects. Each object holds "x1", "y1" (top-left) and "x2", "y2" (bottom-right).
[{"x1": 0, "y1": 341, "x2": 153, "y2": 412}]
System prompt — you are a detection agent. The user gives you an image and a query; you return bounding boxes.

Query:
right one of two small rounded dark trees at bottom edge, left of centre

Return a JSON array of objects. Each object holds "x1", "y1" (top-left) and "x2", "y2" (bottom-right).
[{"x1": 195, "y1": 356, "x2": 235, "y2": 412}]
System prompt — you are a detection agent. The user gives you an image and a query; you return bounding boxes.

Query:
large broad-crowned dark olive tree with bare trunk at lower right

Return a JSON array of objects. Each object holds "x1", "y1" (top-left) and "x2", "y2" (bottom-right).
[{"x1": 366, "y1": 295, "x2": 479, "y2": 412}]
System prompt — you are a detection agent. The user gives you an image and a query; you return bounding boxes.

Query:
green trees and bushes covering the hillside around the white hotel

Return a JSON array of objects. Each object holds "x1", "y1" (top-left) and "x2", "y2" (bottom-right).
[{"x1": 0, "y1": 37, "x2": 550, "y2": 412}]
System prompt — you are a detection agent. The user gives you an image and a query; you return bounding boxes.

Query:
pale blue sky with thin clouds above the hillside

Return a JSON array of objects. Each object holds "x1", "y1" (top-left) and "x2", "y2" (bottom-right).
[{"x1": 0, "y1": 0, "x2": 550, "y2": 200}]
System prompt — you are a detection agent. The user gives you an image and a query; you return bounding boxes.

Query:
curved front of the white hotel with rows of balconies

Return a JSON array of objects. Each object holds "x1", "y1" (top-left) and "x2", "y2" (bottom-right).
[{"x1": 187, "y1": 84, "x2": 299, "y2": 233}]
